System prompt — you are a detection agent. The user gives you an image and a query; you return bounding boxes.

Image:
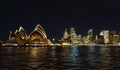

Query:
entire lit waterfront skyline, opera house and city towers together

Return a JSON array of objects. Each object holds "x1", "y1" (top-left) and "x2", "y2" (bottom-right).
[{"x1": 1, "y1": 24, "x2": 120, "y2": 46}]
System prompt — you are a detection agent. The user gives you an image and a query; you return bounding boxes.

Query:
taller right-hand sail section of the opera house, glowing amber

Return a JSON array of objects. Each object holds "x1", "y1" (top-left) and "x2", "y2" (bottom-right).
[{"x1": 28, "y1": 25, "x2": 50, "y2": 44}]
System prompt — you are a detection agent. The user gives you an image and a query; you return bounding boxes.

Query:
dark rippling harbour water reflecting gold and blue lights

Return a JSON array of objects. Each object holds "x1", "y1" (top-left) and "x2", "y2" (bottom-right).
[{"x1": 0, "y1": 46, "x2": 120, "y2": 70}]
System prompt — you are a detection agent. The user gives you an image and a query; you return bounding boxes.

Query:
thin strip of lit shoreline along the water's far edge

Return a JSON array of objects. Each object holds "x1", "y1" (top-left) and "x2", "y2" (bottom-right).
[{"x1": 0, "y1": 43, "x2": 120, "y2": 47}]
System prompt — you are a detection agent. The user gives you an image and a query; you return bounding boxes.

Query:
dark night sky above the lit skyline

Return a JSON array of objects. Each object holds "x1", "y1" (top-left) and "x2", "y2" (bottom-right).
[{"x1": 0, "y1": 0, "x2": 120, "y2": 40}]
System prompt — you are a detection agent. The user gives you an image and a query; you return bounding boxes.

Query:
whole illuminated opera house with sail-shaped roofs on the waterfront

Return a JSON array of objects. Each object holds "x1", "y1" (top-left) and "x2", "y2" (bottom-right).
[{"x1": 5, "y1": 24, "x2": 52, "y2": 46}]
